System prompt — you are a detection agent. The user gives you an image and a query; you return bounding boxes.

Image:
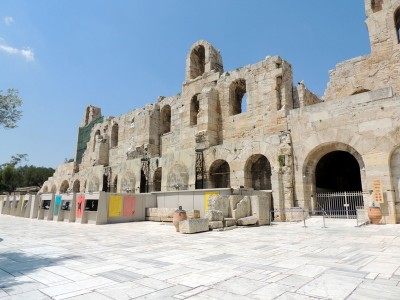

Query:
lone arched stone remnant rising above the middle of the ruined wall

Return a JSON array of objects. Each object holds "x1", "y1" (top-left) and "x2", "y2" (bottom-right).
[{"x1": 186, "y1": 40, "x2": 224, "y2": 81}]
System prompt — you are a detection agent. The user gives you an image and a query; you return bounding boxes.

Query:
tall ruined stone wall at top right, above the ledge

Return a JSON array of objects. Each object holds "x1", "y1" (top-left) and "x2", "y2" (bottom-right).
[{"x1": 324, "y1": 0, "x2": 400, "y2": 101}]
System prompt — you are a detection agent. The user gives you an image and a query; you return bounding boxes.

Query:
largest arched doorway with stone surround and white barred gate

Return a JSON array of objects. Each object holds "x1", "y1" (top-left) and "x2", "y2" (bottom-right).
[{"x1": 299, "y1": 142, "x2": 366, "y2": 217}]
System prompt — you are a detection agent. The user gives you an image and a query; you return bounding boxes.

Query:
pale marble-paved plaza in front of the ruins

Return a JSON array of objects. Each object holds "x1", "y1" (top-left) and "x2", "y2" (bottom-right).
[{"x1": 0, "y1": 215, "x2": 400, "y2": 300}]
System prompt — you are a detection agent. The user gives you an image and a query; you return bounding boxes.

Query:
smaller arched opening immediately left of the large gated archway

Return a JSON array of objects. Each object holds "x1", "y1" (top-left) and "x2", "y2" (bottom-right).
[{"x1": 244, "y1": 154, "x2": 272, "y2": 190}]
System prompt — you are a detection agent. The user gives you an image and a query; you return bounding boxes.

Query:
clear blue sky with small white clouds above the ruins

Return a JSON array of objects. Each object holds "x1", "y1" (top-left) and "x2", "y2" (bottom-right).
[{"x1": 0, "y1": 0, "x2": 370, "y2": 167}]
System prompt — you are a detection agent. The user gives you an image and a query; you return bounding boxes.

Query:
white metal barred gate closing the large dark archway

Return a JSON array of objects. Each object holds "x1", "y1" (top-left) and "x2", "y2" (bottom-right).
[{"x1": 317, "y1": 192, "x2": 364, "y2": 219}]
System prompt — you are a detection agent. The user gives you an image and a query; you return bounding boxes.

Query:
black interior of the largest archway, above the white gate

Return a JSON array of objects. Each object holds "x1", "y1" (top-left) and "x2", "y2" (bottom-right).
[{"x1": 315, "y1": 151, "x2": 362, "y2": 192}]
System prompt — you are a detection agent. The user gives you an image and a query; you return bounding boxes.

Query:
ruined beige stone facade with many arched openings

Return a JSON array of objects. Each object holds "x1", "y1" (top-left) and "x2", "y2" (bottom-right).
[{"x1": 42, "y1": 0, "x2": 400, "y2": 223}]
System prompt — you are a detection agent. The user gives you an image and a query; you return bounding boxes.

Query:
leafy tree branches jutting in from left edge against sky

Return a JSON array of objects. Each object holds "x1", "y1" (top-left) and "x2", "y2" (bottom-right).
[{"x1": 0, "y1": 89, "x2": 22, "y2": 128}]
